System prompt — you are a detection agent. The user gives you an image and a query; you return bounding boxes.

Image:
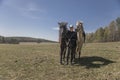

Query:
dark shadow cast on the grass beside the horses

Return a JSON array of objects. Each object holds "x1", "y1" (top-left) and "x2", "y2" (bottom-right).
[{"x1": 75, "y1": 56, "x2": 115, "y2": 69}]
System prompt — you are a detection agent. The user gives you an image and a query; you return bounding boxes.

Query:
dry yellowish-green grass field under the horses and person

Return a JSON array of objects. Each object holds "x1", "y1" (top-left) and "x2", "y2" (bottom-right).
[{"x1": 0, "y1": 42, "x2": 120, "y2": 80}]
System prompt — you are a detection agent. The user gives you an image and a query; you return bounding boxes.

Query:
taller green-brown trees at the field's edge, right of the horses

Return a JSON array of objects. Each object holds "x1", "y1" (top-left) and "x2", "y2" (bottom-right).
[{"x1": 86, "y1": 17, "x2": 120, "y2": 42}]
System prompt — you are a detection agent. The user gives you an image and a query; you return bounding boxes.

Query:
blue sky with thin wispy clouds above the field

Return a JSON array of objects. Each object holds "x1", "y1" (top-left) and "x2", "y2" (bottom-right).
[{"x1": 0, "y1": 0, "x2": 120, "y2": 41}]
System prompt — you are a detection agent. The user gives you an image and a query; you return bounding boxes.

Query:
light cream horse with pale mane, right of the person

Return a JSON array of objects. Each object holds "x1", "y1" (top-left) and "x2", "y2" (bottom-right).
[{"x1": 76, "y1": 21, "x2": 85, "y2": 59}]
